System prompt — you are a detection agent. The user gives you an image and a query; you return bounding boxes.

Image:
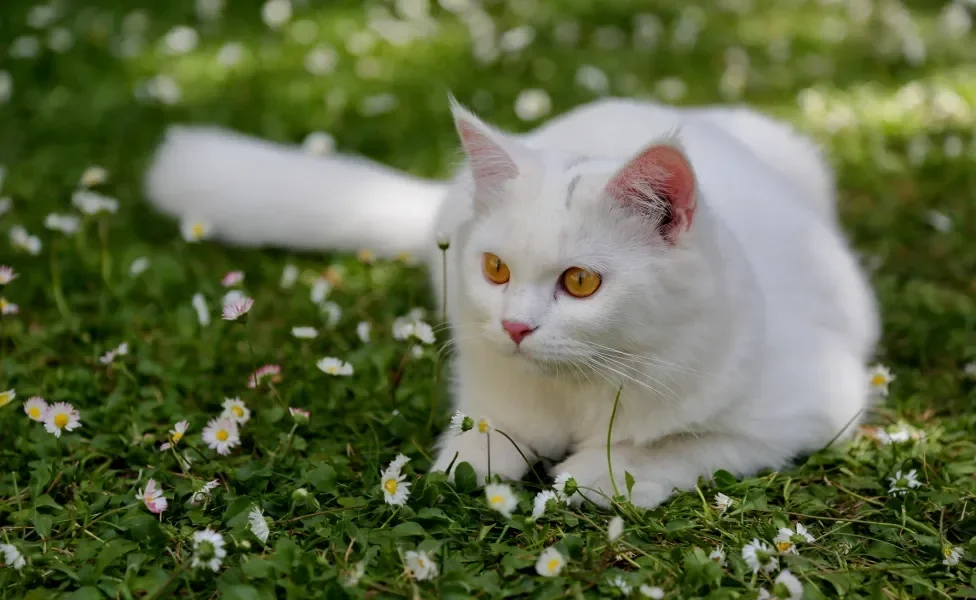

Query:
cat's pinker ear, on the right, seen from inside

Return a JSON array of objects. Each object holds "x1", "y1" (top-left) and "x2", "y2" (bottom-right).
[{"x1": 607, "y1": 137, "x2": 698, "y2": 243}]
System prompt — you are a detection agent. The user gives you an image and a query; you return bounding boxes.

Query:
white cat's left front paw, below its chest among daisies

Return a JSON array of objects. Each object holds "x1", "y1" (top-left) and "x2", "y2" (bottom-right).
[{"x1": 431, "y1": 428, "x2": 536, "y2": 482}]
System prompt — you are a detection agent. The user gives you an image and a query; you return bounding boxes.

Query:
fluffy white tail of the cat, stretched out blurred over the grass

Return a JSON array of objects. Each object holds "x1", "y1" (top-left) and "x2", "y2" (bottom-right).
[{"x1": 146, "y1": 126, "x2": 446, "y2": 258}]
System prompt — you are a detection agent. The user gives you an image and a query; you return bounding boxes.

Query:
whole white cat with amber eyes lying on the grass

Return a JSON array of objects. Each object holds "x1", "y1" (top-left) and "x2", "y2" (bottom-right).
[{"x1": 148, "y1": 99, "x2": 879, "y2": 507}]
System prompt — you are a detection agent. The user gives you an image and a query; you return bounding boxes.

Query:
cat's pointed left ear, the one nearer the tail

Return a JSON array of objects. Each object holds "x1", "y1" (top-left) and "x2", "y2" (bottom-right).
[{"x1": 448, "y1": 95, "x2": 523, "y2": 205}]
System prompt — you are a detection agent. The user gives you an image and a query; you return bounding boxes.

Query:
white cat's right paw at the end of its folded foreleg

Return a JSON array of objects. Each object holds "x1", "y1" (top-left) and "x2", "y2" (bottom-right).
[{"x1": 552, "y1": 450, "x2": 671, "y2": 509}]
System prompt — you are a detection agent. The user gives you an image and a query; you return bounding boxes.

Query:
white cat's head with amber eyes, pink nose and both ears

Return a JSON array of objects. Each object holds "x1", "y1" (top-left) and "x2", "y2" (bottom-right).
[{"x1": 452, "y1": 99, "x2": 703, "y2": 369}]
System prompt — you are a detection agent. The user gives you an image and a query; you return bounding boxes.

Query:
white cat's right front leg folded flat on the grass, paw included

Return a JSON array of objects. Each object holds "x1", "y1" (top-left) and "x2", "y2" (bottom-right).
[{"x1": 552, "y1": 434, "x2": 782, "y2": 509}]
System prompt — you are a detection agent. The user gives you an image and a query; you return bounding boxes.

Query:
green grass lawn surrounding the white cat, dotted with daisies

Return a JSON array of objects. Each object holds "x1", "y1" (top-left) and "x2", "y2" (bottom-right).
[{"x1": 0, "y1": 0, "x2": 976, "y2": 600}]
